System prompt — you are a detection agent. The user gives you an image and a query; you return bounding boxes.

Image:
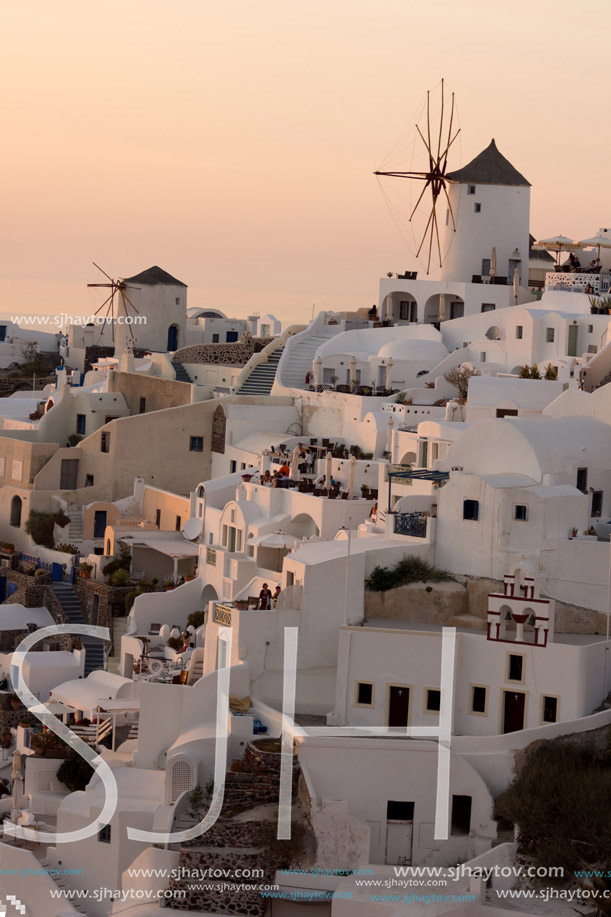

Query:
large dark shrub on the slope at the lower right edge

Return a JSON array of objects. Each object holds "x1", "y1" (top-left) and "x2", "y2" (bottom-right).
[{"x1": 495, "y1": 741, "x2": 611, "y2": 881}]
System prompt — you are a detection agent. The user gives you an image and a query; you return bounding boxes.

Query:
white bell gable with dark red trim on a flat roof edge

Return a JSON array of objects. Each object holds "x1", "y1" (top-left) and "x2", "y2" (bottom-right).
[{"x1": 487, "y1": 563, "x2": 554, "y2": 647}]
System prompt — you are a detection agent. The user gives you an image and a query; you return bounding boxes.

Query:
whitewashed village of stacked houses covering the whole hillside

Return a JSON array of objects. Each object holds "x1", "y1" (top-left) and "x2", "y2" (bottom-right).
[{"x1": 0, "y1": 142, "x2": 611, "y2": 917}]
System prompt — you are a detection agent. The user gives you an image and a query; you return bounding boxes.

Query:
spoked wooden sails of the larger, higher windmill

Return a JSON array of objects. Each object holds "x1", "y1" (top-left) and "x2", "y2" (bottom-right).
[{"x1": 373, "y1": 80, "x2": 460, "y2": 274}]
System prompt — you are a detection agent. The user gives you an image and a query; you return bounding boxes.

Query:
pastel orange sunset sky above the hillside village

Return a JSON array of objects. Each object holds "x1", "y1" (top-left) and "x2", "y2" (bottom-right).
[{"x1": 0, "y1": 0, "x2": 611, "y2": 321}]
